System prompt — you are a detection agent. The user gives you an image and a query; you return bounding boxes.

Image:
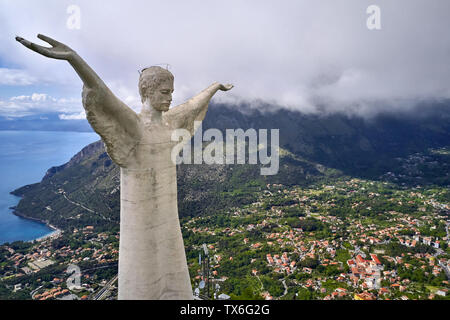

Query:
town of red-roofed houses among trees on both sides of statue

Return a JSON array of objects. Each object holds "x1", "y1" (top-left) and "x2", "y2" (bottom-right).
[{"x1": 0, "y1": 177, "x2": 450, "y2": 300}]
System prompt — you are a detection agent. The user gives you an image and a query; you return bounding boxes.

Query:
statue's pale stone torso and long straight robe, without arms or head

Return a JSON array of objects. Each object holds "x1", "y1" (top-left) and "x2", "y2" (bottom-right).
[{"x1": 119, "y1": 113, "x2": 192, "y2": 299}]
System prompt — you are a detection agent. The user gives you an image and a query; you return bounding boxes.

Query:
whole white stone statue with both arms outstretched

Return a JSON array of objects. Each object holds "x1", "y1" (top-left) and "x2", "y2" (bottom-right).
[{"x1": 16, "y1": 35, "x2": 233, "y2": 299}]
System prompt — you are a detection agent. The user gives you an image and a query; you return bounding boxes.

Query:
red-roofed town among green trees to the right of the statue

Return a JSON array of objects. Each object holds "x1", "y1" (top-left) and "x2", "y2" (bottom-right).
[{"x1": 184, "y1": 179, "x2": 450, "y2": 300}]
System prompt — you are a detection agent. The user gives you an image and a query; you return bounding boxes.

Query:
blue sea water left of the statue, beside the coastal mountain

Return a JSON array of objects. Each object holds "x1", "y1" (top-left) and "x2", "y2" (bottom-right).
[{"x1": 0, "y1": 131, "x2": 99, "y2": 244}]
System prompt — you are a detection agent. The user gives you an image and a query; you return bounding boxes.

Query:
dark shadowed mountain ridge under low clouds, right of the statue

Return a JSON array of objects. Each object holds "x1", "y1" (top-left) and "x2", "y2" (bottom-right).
[{"x1": 203, "y1": 101, "x2": 450, "y2": 178}]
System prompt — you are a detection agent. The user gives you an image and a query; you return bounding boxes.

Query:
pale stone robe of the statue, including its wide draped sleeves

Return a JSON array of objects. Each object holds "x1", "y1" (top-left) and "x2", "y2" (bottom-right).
[{"x1": 83, "y1": 88, "x2": 199, "y2": 300}]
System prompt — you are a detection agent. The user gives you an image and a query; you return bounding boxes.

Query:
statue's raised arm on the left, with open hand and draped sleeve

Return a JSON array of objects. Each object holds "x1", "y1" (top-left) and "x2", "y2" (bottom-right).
[{"x1": 16, "y1": 34, "x2": 140, "y2": 166}]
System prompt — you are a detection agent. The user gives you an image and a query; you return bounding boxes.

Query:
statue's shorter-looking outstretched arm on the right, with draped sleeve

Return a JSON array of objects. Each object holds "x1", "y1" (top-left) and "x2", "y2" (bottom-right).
[{"x1": 164, "y1": 82, "x2": 233, "y2": 135}]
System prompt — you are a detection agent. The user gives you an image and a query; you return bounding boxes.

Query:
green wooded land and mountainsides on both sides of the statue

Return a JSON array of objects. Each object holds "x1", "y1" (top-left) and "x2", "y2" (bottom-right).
[{"x1": 0, "y1": 103, "x2": 450, "y2": 300}]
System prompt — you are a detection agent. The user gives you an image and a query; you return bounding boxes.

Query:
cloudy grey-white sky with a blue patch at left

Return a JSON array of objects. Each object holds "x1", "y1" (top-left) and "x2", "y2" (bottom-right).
[{"x1": 0, "y1": 0, "x2": 450, "y2": 120}]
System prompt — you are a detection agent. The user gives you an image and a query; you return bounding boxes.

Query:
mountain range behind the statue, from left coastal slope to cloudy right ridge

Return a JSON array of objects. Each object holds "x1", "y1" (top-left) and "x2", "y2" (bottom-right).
[{"x1": 13, "y1": 104, "x2": 450, "y2": 230}]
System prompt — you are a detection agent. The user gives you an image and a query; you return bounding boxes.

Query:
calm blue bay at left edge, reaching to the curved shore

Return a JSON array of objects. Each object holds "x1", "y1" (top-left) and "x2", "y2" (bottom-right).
[{"x1": 0, "y1": 130, "x2": 99, "y2": 243}]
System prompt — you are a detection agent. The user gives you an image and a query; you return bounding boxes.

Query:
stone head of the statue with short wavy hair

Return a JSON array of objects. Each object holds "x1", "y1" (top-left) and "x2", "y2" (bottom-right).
[{"x1": 139, "y1": 66, "x2": 174, "y2": 111}]
